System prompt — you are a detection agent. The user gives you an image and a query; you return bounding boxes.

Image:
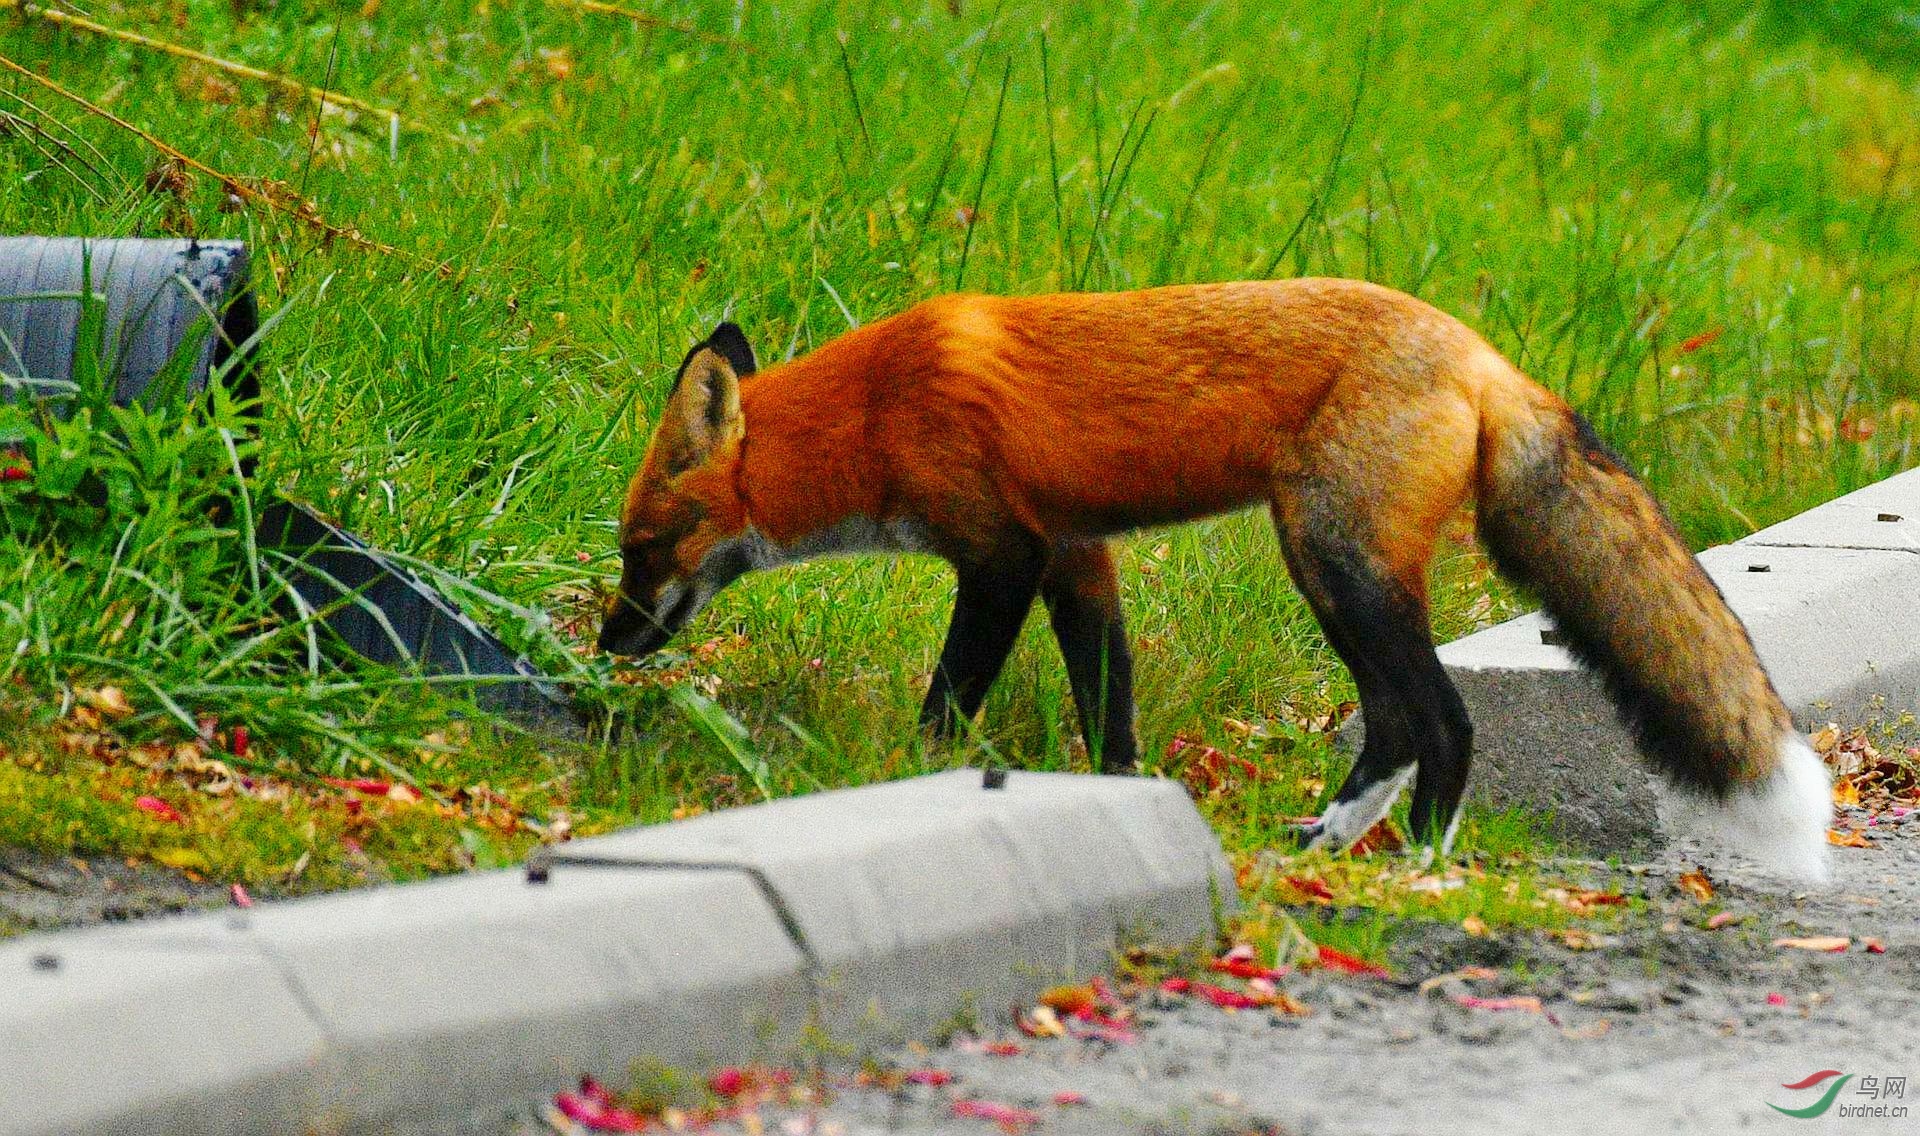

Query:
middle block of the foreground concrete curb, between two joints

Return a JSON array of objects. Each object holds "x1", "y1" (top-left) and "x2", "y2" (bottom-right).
[{"x1": 248, "y1": 871, "x2": 810, "y2": 1130}]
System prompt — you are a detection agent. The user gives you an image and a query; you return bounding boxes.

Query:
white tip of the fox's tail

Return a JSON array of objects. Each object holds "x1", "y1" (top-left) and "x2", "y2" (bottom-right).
[{"x1": 1692, "y1": 733, "x2": 1834, "y2": 885}]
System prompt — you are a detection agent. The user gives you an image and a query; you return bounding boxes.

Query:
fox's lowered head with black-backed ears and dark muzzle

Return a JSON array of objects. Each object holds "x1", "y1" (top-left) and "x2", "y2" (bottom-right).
[{"x1": 599, "y1": 322, "x2": 755, "y2": 654}]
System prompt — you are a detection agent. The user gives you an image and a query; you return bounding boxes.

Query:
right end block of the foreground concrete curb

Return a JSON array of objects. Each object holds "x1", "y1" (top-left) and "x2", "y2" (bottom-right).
[{"x1": 576, "y1": 769, "x2": 1235, "y2": 1046}]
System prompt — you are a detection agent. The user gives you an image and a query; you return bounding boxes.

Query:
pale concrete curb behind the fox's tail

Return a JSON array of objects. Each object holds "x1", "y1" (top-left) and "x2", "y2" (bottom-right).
[{"x1": 1342, "y1": 470, "x2": 1920, "y2": 852}]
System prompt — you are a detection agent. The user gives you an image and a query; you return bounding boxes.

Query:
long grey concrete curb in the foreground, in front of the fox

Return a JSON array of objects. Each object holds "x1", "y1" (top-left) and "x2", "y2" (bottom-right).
[{"x1": 0, "y1": 769, "x2": 1235, "y2": 1136}]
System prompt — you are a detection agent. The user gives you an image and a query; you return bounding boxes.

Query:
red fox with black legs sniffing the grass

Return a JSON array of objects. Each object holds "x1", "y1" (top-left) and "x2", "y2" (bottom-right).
[{"x1": 599, "y1": 280, "x2": 1832, "y2": 877}]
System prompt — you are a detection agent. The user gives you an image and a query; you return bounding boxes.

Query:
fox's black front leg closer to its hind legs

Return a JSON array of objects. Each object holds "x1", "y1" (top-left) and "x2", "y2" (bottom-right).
[{"x1": 1041, "y1": 543, "x2": 1140, "y2": 773}]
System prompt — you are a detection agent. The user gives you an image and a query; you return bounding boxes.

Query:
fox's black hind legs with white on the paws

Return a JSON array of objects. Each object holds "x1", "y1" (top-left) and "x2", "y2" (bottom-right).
[{"x1": 1275, "y1": 501, "x2": 1473, "y2": 852}]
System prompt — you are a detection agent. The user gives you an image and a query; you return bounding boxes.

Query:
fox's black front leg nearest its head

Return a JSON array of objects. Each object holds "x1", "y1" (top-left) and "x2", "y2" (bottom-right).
[{"x1": 920, "y1": 555, "x2": 1041, "y2": 737}]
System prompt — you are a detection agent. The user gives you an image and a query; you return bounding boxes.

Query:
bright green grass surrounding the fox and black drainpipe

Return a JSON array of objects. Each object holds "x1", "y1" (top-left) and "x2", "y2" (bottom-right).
[{"x1": 0, "y1": 0, "x2": 1920, "y2": 932}]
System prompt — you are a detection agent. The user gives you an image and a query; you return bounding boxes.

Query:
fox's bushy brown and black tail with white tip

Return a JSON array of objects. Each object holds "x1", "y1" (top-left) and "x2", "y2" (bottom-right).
[{"x1": 1478, "y1": 372, "x2": 1834, "y2": 881}]
